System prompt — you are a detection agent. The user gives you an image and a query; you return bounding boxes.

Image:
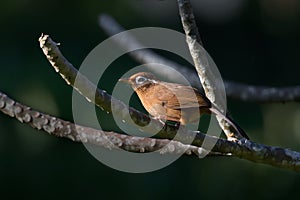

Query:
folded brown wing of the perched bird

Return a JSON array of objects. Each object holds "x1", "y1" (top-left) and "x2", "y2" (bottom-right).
[{"x1": 156, "y1": 82, "x2": 210, "y2": 109}]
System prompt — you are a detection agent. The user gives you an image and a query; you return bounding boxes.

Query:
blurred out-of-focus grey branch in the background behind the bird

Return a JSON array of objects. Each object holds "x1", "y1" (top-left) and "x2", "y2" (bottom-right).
[{"x1": 99, "y1": 14, "x2": 300, "y2": 103}]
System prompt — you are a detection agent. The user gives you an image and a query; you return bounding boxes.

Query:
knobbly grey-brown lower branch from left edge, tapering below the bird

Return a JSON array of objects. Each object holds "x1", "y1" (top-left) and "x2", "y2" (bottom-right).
[{"x1": 0, "y1": 92, "x2": 210, "y2": 156}]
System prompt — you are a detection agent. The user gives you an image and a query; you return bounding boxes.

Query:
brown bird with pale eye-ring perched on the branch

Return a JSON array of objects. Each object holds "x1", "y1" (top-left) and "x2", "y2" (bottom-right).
[{"x1": 119, "y1": 72, "x2": 249, "y2": 139}]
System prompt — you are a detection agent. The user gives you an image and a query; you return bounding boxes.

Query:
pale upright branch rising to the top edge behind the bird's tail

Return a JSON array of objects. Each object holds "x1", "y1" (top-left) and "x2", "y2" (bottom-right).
[{"x1": 178, "y1": 0, "x2": 238, "y2": 140}]
